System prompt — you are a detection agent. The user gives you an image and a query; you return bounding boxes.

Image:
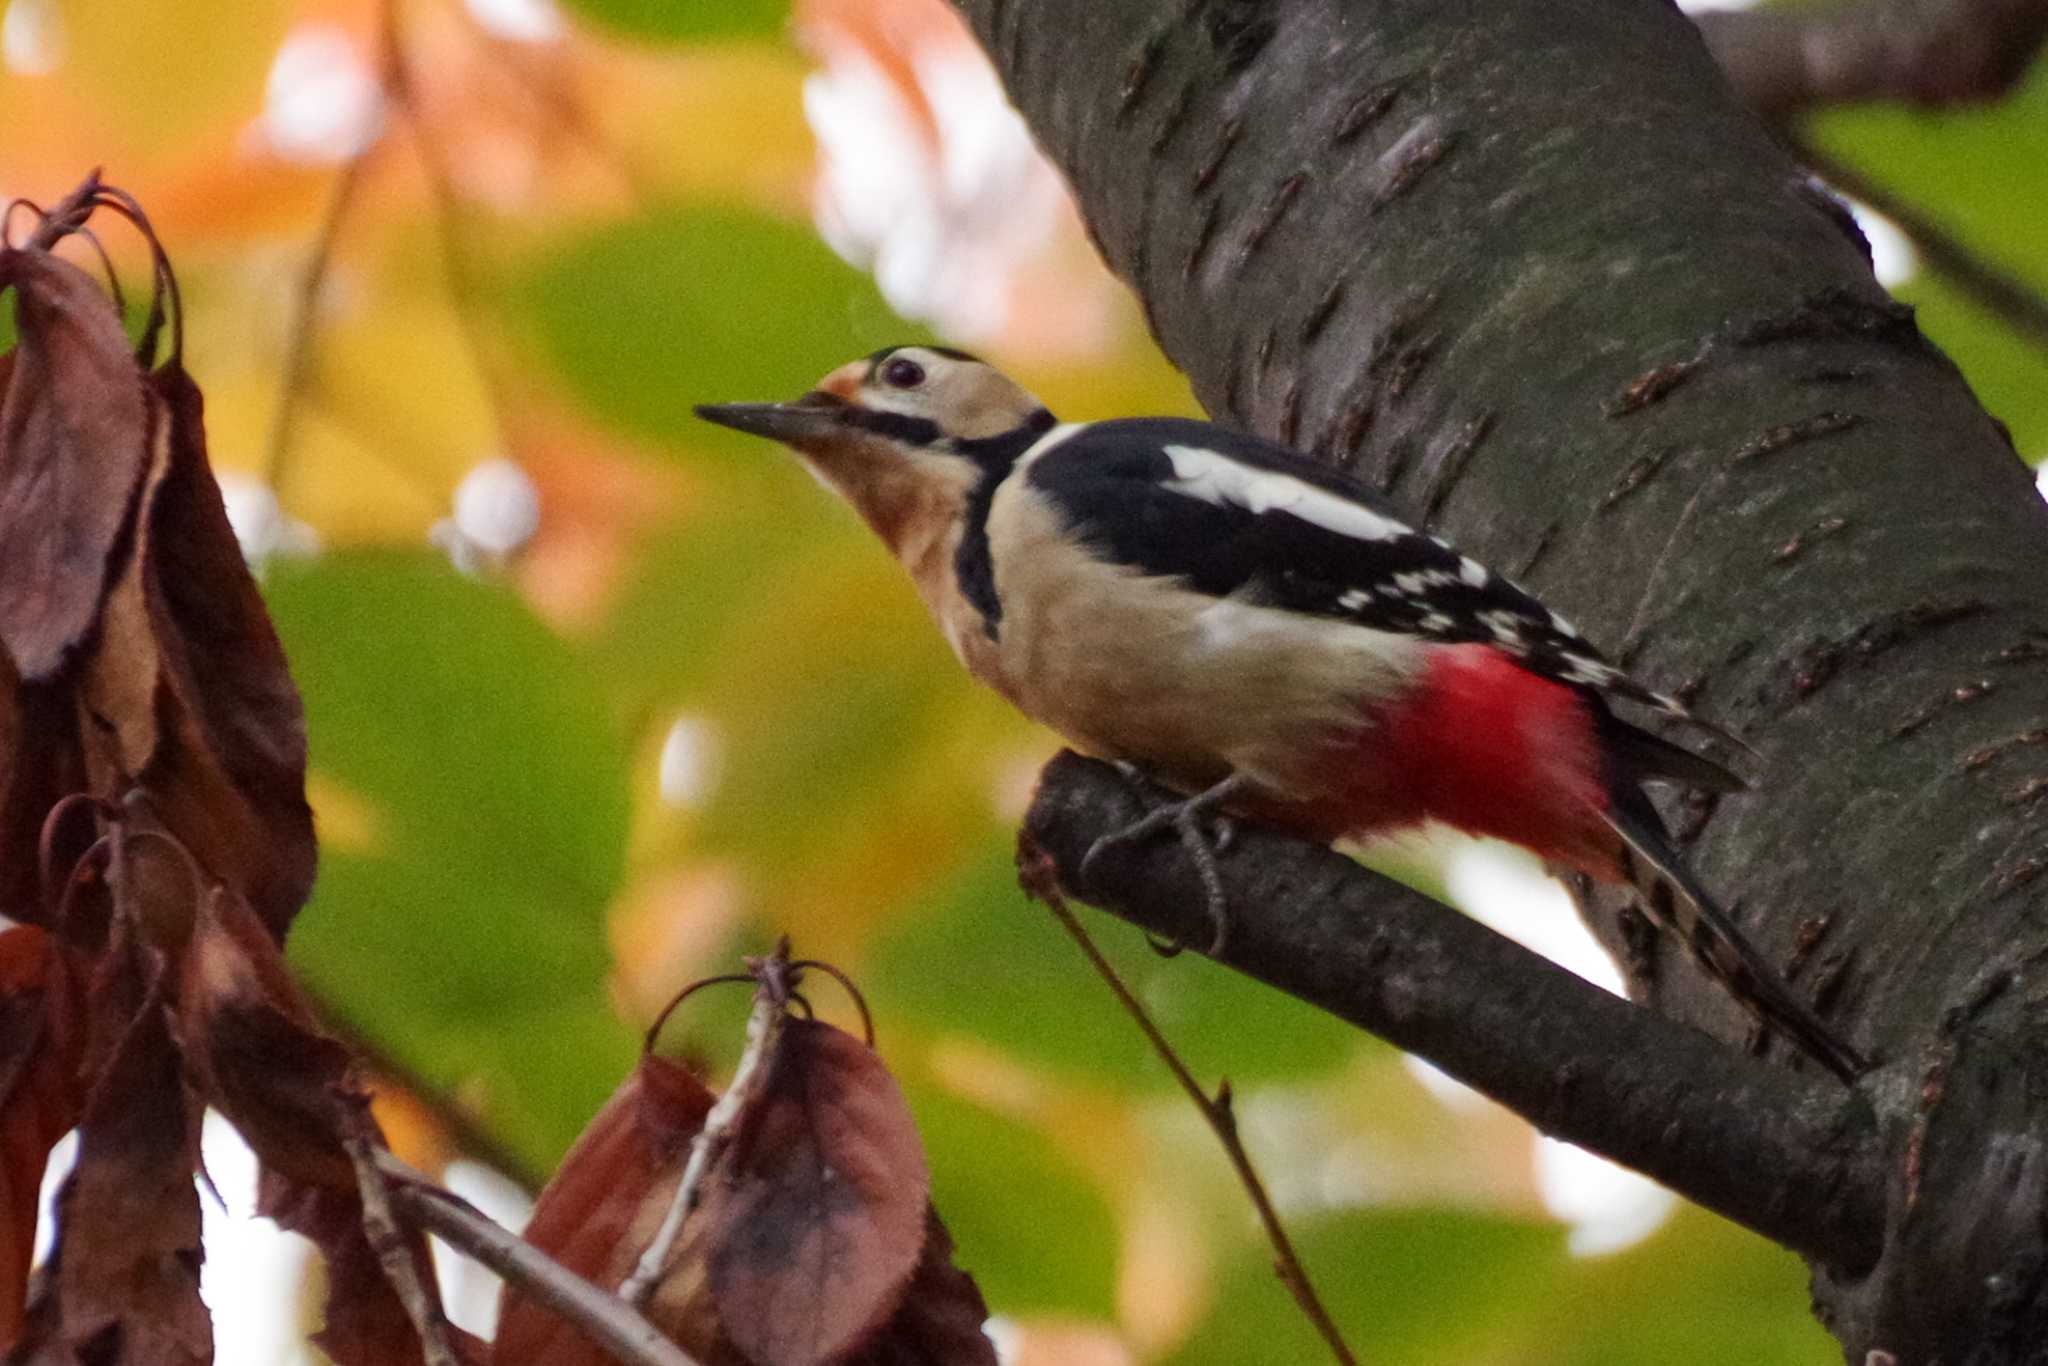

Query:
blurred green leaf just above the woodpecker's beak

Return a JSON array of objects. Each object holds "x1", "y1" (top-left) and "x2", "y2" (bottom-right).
[{"x1": 514, "y1": 207, "x2": 926, "y2": 459}]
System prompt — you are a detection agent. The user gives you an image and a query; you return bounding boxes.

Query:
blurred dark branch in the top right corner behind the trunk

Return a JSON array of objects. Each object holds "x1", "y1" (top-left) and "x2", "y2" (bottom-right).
[{"x1": 1694, "y1": 0, "x2": 2048, "y2": 119}]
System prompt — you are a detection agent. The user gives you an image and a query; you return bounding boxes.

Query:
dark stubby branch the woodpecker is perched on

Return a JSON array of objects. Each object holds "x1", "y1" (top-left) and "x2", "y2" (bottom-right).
[{"x1": 1024, "y1": 754, "x2": 1884, "y2": 1272}]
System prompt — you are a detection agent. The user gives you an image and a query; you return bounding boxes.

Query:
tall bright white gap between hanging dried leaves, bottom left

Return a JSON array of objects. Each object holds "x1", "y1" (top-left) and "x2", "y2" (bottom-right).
[{"x1": 199, "y1": 1110, "x2": 317, "y2": 1366}]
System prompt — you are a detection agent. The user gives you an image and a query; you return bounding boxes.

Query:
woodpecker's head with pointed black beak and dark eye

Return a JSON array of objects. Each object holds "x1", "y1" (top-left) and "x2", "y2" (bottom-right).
[{"x1": 696, "y1": 346, "x2": 1053, "y2": 553}]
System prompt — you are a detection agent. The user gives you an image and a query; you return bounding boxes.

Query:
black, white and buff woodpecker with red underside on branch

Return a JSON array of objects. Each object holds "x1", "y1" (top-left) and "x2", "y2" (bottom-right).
[{"x1": 696, "y1": 346, "x2": 1866, "y2": 1081}]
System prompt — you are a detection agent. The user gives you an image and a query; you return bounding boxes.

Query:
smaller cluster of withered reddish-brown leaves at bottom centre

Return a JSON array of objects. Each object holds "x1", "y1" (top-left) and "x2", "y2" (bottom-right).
[{"x1": 503, "y1": 966, "x2": 995, "y2": 1366}]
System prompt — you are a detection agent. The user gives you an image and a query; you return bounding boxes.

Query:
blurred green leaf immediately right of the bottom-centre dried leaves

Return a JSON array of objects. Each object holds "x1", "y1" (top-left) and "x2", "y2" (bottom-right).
[{"x1": 903, "y1": 1083, "x2": 1116, "y2": 1319}]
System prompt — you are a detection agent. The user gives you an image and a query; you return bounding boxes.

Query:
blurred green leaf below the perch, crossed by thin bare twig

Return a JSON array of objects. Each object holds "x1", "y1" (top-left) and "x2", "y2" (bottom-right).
[{"x1": 862, "y1": 831, "x2": 1372, "y2": 1092}]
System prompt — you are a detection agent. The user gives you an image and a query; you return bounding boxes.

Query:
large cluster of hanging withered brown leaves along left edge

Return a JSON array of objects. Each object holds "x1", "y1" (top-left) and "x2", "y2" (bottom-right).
[{"x1": 0, "y1": 176, "x2": 481, "y2": 1366}]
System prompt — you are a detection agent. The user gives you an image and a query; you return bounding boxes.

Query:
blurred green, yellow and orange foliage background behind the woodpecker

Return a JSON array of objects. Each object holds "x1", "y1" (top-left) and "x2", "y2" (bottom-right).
[{"x1": 0, "y1": 0, "x2": 2048, "y2": 1366}]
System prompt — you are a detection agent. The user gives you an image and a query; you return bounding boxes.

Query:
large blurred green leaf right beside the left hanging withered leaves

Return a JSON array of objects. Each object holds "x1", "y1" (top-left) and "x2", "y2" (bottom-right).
[{"x1": 266, "y1": 553, "x2": 635, "y2": 1171}]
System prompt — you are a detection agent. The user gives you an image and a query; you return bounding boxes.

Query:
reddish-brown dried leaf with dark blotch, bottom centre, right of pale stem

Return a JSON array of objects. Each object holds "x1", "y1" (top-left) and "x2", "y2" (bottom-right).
[{"x1": 696, "y1": 1020, "x2": 932, "y2": 1366}]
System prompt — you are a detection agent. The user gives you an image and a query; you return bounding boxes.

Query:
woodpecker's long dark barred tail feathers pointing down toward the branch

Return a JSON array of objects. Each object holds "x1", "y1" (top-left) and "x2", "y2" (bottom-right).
[{"x1": 1604, "y1": 793, "x2": 1870, "y2": 1083}]
